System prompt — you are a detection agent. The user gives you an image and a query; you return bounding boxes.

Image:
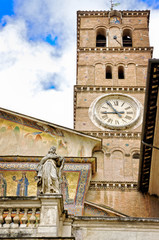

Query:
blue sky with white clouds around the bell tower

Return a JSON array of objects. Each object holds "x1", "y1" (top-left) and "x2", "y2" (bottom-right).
[{"x1": 0, "y1": 0, "x2": 159, "y2": 128}]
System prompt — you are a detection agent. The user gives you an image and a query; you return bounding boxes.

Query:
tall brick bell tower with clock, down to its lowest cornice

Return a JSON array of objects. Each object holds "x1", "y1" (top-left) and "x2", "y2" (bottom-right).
[{"x1": 74, "y1": 10, "x2": 153, "y2": 182}]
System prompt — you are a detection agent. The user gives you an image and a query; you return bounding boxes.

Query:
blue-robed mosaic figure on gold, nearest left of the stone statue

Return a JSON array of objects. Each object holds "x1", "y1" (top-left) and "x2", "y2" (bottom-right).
[{"x1": 13, "y1": 172, "x2": 29, "y2": 196}]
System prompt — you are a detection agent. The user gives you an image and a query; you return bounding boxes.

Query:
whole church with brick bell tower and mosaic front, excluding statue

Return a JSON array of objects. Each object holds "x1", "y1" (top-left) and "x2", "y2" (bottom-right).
[{"x1": 0, "y1": 10, "x2": 159, "y2": 240}]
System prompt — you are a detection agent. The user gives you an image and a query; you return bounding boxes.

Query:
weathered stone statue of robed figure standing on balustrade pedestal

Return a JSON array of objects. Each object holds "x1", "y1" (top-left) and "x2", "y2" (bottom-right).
[{"x1": 37, "y1": 146, "x2": 64, "y2": 194}]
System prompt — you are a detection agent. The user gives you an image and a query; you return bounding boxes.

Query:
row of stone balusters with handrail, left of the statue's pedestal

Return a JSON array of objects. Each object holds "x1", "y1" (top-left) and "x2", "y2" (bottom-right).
[{"x1": 0, "y1": 198, "x2": 41, "y2": 228}]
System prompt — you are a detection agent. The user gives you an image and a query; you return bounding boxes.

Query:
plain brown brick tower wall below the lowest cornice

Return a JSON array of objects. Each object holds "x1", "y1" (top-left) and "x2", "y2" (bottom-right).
[{"x1": 86, "y1": 190, "x2": 159, "y2": 218}]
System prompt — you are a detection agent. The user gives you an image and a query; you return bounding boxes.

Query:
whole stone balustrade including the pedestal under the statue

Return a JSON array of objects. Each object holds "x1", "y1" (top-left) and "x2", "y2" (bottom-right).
[{"x1": 0, "y1": 194, "x2": 71, "y2": 240}]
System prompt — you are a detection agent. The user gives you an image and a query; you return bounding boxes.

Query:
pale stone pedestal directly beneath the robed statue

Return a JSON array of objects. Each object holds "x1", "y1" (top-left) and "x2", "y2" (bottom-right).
[{"x1": 38, "y1": 194, "x2": 64, "y2": 237}]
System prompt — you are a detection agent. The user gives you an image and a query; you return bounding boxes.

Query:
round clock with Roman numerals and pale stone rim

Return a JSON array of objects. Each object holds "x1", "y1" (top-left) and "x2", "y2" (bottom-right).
[{"x1": 89, "y1": 93, "x2": 142, "y2": 130}]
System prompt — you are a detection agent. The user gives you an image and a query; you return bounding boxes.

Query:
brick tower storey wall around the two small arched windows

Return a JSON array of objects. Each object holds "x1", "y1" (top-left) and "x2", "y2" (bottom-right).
[{"x1": 77, "y1": 51, "x2": 151, "y2": 86}]
